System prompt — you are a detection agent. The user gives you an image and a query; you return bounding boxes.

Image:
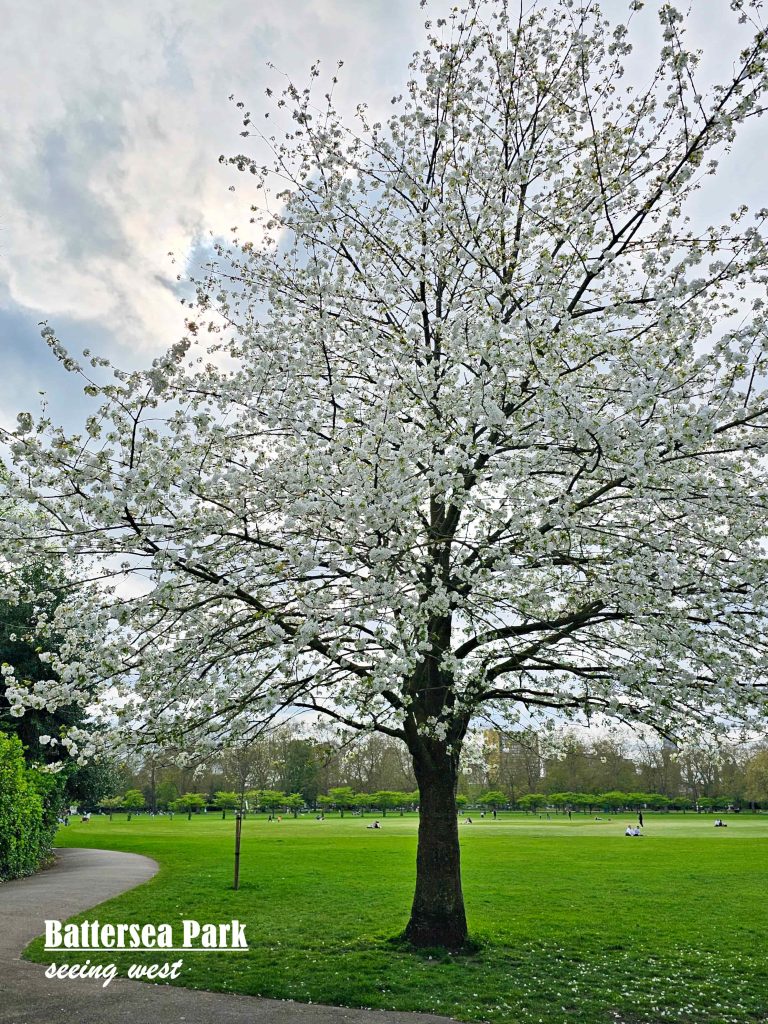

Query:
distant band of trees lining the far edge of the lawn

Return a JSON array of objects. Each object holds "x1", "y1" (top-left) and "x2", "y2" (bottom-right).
[{"x1": 109, "y1": 725, "x2": 768, "y2": 810}]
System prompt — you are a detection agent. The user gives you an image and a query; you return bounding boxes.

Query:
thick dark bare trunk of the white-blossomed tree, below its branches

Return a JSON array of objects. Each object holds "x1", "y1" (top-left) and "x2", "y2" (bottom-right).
[{"x1": 404, "y1": 744, "x2": 467, "y2": 949}]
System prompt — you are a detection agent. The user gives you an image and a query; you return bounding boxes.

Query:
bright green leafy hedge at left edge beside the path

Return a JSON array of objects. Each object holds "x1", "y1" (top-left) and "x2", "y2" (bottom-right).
[{"x1": 0, "y1": 733, "x2": 61, "y2": 881}]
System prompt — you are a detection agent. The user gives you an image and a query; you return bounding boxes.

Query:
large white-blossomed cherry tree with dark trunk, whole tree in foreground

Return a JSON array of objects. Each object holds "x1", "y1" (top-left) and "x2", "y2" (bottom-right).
[{"x1": 4, "y1": 0, "x2": 768, "y2": 947}]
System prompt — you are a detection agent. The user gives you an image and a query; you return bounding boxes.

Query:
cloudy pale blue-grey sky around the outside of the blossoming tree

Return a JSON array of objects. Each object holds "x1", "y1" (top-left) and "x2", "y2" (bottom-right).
[{"x1": 0, "y1": 0, "x2": 768, "y2": 428}]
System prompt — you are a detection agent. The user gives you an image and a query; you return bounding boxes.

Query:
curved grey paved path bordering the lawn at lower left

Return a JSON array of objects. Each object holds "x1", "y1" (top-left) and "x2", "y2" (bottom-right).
[{"x1": 0, "y1": 849, "x2": 447, "y2": 1024}]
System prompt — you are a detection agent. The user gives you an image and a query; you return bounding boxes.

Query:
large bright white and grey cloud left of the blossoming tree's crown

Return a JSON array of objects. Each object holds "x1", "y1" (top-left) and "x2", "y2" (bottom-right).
[{"x1": 0, "y1": 0, "x2": 421, "y2": 352}]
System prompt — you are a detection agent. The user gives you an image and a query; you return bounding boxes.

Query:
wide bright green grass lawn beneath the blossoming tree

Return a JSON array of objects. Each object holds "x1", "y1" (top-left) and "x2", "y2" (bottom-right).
[{"x1": 28, "y1": 814, "x2": 768, "y2": 1024}]
